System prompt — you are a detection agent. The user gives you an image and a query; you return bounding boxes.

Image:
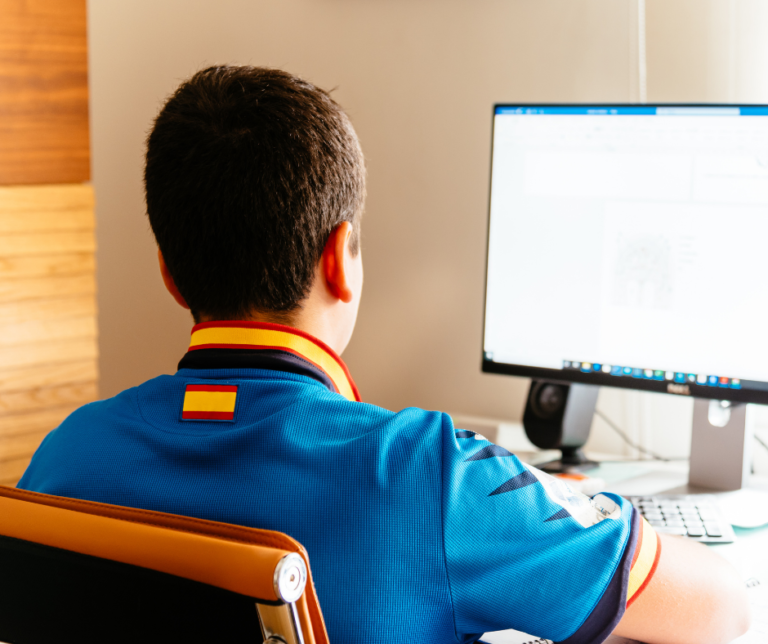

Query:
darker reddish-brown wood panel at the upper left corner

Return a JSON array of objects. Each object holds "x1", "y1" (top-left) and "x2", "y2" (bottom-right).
[{"x1": 0, "y1": 0, "x2": 90, "y2": 185}]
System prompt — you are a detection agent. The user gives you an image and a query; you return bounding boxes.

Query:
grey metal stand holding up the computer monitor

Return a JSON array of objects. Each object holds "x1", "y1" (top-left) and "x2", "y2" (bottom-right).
[{"x1": 688, "y1": 398, "x2": 754, "y2": 491}]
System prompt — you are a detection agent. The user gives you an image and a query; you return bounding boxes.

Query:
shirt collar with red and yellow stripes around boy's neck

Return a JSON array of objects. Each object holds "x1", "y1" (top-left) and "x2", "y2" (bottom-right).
[{"x1": 179, "y1": 321, "x2": 360, "y2": 401}]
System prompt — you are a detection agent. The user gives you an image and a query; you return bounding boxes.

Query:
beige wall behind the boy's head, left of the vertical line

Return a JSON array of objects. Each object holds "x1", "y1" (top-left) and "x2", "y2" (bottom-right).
[{"x1": 89, "y1": 0, "x2": 636, "y2": 418}]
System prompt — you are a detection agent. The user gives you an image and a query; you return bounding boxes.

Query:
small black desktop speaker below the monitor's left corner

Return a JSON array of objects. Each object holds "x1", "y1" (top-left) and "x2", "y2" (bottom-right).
[{"x1": 523, "y1": 380, "x2": 600, "y2": 472}]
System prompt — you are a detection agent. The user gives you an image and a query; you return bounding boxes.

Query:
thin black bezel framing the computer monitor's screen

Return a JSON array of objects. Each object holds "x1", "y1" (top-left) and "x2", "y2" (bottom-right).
[{"x1": 480, "y1": 103, "x2": 768, "y2": 405}]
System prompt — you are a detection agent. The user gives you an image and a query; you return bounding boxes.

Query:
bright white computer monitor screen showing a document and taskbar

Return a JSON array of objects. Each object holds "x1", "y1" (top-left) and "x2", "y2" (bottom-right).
[{"x1": 483, "y1": 105, "x2": 768, "y2": 403}]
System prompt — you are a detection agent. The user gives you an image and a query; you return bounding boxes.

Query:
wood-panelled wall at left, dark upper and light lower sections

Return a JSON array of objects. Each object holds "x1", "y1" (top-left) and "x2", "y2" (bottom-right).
[{"x1": 0, "y1": 0, "x2": 98, "y2": 484}]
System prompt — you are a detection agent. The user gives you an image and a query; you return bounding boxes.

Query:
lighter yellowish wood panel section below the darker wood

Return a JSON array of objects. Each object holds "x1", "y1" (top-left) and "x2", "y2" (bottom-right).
[{"x1": 0, "y1": 182, "x2": 98, "y2": 484}]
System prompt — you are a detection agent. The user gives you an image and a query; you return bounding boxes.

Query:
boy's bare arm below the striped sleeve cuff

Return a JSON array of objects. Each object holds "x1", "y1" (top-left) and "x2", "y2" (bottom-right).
[{"x1": 614, "y1": 535, "x2": 750, "y2": 644}]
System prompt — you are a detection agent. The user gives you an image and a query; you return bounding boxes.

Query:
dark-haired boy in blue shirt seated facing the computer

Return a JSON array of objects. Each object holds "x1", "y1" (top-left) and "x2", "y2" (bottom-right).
[{"x1": 19, "y1": 67, "x2": 748, "y2": 644}]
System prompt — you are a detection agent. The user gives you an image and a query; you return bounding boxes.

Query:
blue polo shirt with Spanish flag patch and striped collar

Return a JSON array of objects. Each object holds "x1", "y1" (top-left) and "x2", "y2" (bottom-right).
[{"x1": 19, "y1": 322, "x2": 660, "y2": 644}]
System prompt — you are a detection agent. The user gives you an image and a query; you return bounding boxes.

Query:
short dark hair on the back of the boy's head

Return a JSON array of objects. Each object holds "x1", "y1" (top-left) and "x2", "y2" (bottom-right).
[{"x1": 144, "y1": 66, "x2": 365, "y2": 321}]
